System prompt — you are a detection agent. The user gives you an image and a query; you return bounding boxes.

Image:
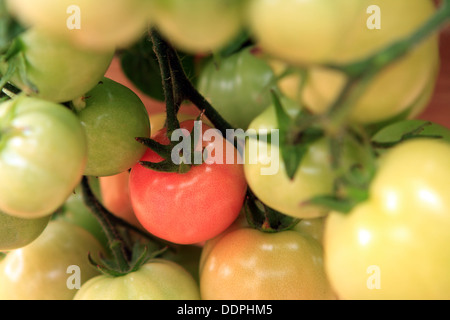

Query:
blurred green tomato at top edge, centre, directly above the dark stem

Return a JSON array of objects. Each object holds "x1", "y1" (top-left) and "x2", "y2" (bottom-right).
[{"x1": 152, "y1": 0, "x2": 246, "y2": 53}]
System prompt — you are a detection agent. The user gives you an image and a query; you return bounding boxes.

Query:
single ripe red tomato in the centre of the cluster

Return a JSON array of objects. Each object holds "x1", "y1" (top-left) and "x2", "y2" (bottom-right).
[{"x1": 129, "y1": 121, "x2": 247, "y2": 244}]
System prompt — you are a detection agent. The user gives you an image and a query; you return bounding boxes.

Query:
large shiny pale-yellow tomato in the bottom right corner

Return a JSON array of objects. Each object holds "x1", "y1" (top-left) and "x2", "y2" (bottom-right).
[{"x1": 324, "y1": 139, "x2": 450, "y2": 300}]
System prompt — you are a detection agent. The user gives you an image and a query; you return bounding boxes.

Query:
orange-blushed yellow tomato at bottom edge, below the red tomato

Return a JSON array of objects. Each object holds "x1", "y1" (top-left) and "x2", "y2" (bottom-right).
[{"x1": 200, "y1": 228, "x2": 335, "y2": 300}]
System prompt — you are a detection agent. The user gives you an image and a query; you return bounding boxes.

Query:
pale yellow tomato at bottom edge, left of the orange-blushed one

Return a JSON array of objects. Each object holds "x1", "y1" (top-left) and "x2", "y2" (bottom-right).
[{"x1": 74, "y1": 259, "x2": 200, "y2": 300}]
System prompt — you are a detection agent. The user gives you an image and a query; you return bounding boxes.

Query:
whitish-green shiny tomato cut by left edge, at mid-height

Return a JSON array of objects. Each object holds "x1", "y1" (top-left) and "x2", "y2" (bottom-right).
[{"x1": 0, "y1": 96, "x2": 87, "y2": 218}]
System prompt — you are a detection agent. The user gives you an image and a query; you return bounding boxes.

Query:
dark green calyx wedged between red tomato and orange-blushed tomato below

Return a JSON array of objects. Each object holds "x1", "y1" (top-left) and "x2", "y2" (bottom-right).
[{"x1": 244, "y1": 190, "x2": 301, "y2": 233}]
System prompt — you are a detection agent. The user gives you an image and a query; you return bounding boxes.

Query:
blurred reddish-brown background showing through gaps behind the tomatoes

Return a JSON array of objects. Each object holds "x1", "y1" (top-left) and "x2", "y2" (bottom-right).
[{"x1": 106, "y1": 27, "x2": 450, "y2": 128}]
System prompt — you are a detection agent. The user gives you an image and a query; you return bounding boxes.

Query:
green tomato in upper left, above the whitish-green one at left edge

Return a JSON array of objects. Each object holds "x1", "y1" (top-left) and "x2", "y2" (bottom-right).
[{"x1": 0, "y1": 29, "x2": 114, "y2": 103}]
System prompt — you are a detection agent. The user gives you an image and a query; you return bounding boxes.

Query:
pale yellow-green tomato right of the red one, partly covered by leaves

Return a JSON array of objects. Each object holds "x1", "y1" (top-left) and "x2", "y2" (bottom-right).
[{"x1": 244, "y1": 106, "x2": 368, "y2": 219}]
